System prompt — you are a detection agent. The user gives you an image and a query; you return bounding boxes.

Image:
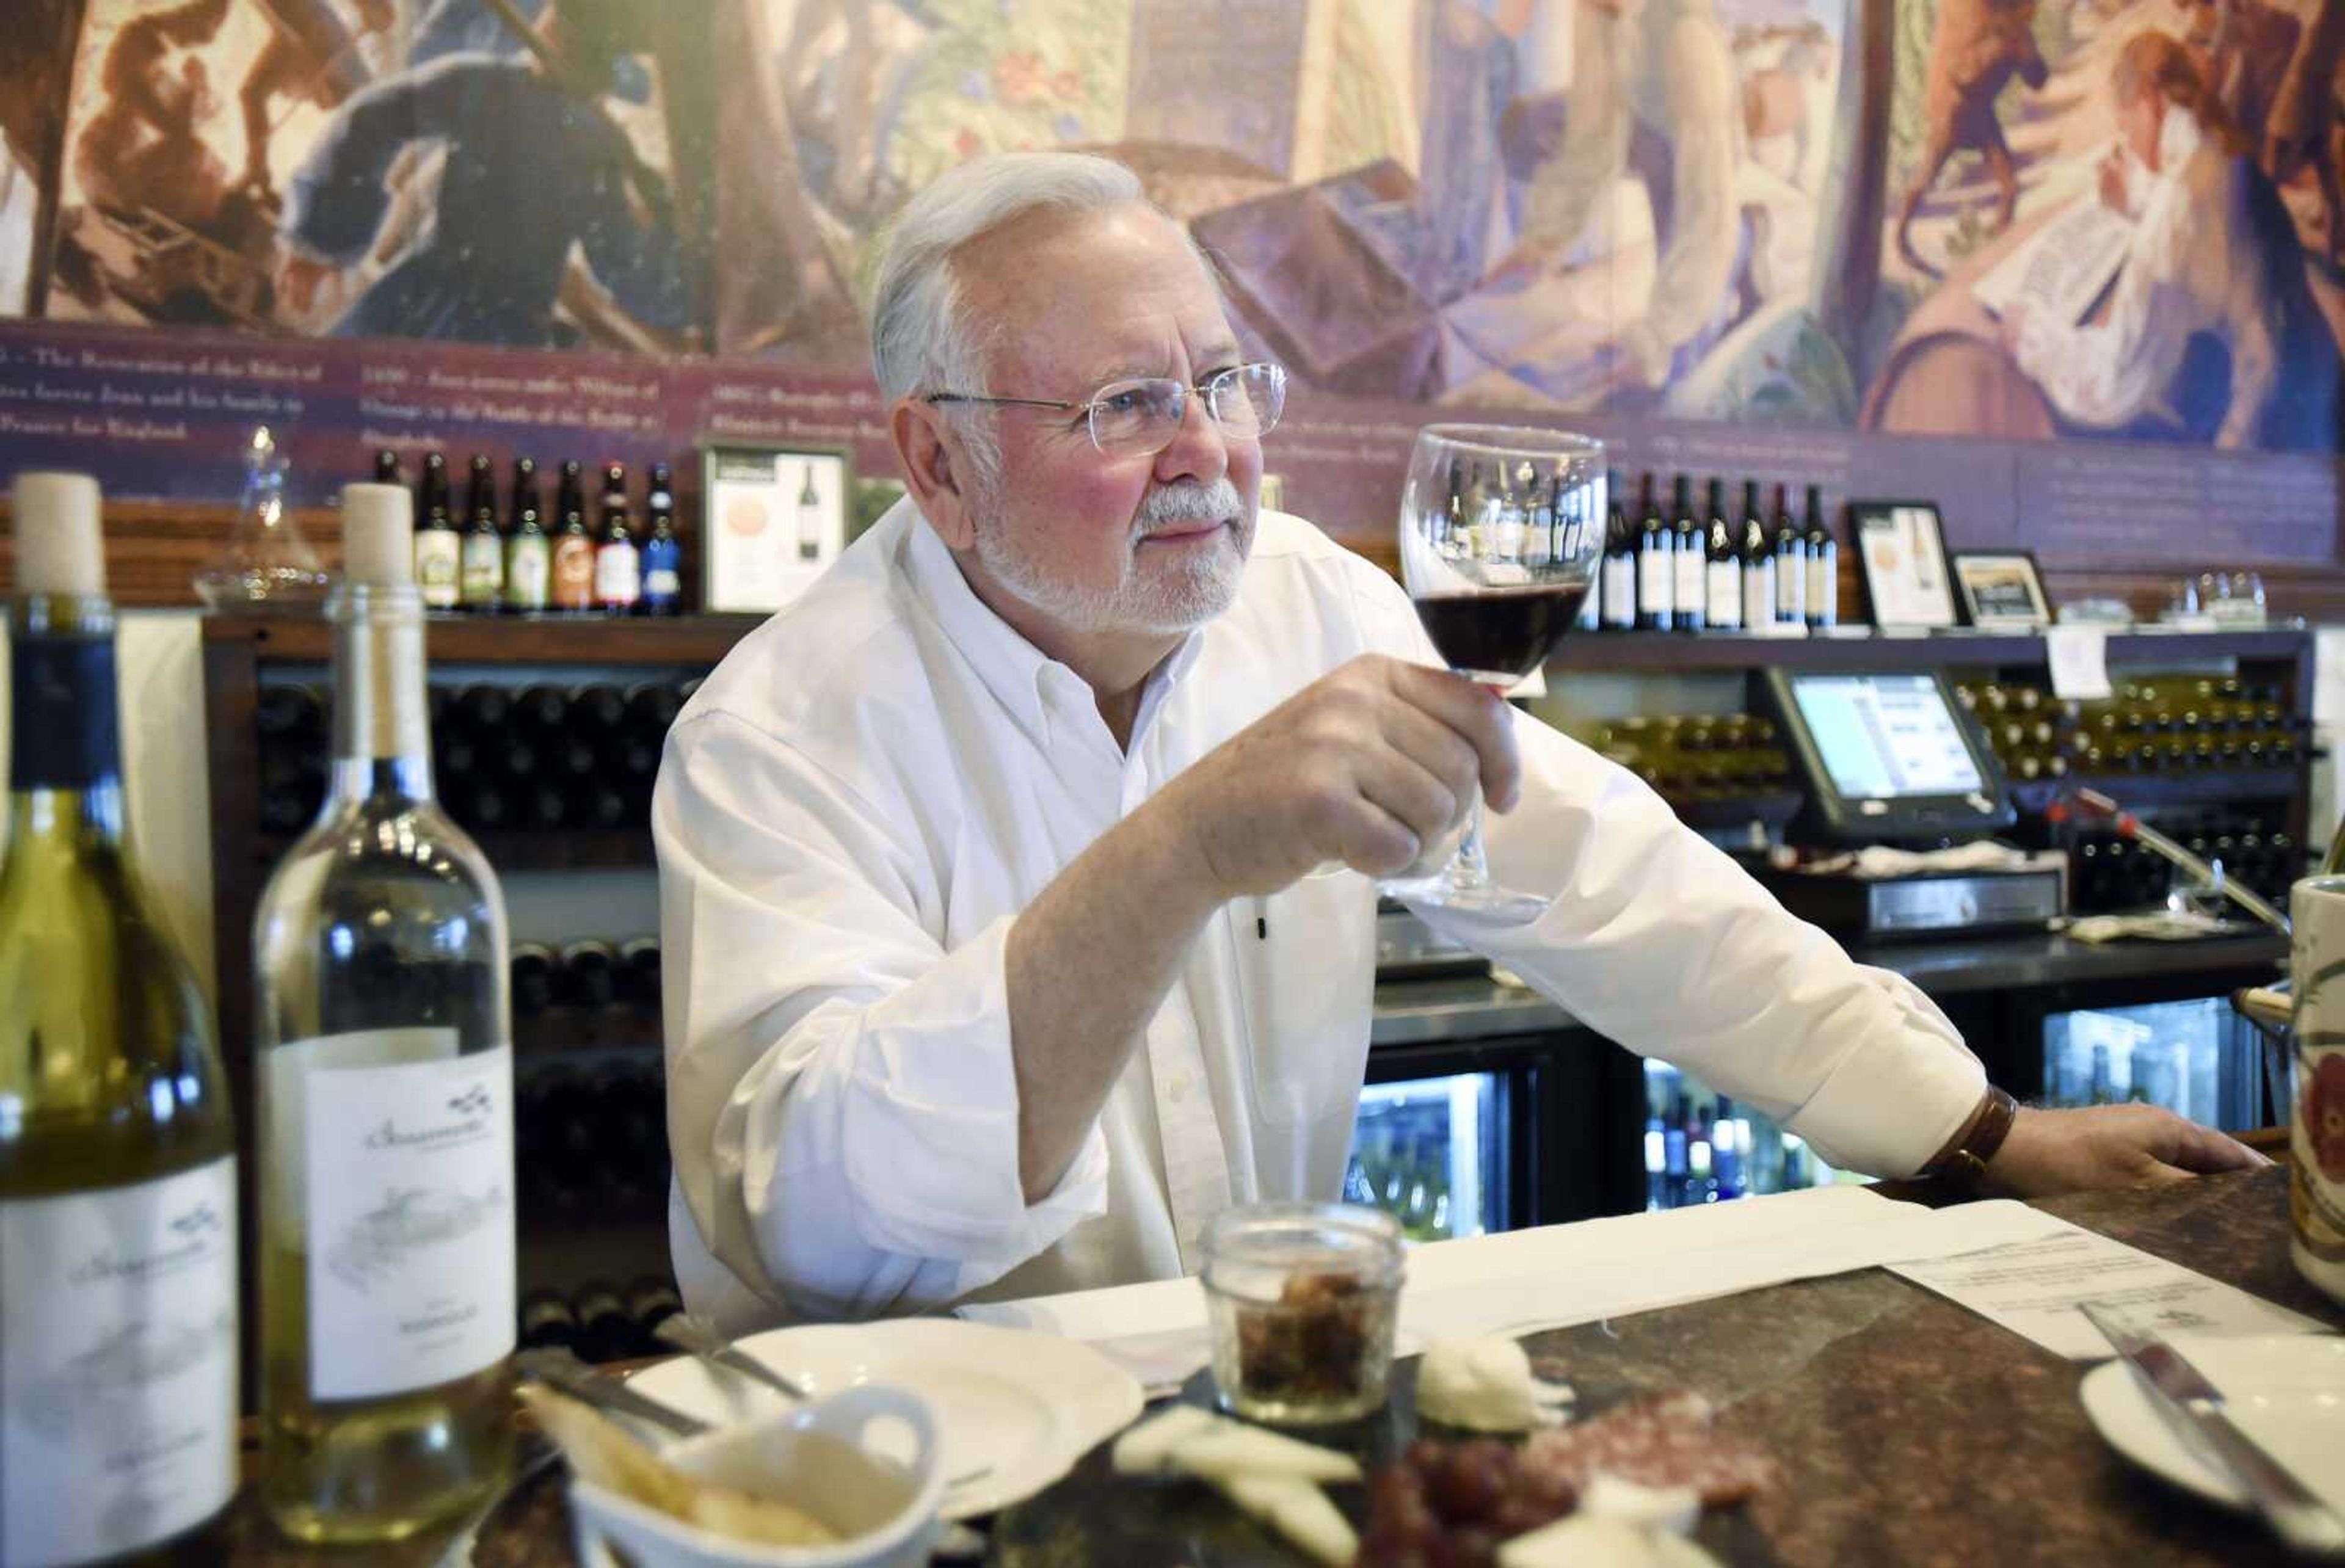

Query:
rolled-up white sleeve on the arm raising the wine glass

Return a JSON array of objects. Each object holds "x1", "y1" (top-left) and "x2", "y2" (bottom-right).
[{"x1": 652, "y1": 710, "x2": 1107, "y2": 1317}]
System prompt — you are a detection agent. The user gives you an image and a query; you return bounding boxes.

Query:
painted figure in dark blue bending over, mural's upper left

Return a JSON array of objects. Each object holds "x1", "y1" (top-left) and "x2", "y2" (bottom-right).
[{"x1": 282, "y1": 0, "x2": 689, "y2": 347}]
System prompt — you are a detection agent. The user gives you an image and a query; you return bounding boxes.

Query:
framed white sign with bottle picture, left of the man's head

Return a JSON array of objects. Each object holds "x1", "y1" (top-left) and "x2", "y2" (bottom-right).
[{"x1": 701, "y1": 443, "x2": 856, "y2": 614}]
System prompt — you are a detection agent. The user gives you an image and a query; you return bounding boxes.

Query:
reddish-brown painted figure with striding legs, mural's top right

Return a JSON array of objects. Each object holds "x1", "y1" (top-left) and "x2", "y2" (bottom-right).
[{"x1": 1897, "y1": 0, "x2": 2049, "y2": 277}]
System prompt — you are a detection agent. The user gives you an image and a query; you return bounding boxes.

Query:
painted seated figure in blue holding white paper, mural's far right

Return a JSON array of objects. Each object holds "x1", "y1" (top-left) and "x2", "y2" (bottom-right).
[{"x1": 2005, "y1": 33, "x2": 2338, "y2": 450}]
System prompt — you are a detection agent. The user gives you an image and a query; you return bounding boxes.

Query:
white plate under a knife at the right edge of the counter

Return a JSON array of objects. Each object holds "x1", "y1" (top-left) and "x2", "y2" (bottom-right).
[{"x1": 2078, "y1": 1334, "x2": 2345, "y2": 1507}]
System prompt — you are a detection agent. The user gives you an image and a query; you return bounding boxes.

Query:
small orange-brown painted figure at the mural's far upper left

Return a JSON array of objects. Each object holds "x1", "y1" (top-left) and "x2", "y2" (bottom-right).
[{"x1": 73, "y1": 0, "x2": 227, "y2": 230}]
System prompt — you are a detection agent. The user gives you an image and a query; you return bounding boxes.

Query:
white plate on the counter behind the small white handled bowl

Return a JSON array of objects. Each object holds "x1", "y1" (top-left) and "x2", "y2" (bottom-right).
[{"x1": 628, "y1": 1317, "x2": 1142, "y2": 1519}]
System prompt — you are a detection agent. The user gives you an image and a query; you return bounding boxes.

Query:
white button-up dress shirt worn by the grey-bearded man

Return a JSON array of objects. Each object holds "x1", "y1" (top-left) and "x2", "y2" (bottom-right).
[{"x1": 652, "y1": 504, "x2": 1984, "y2": 1331}]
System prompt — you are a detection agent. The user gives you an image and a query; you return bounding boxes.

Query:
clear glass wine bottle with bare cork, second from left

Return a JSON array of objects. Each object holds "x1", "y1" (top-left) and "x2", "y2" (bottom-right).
[{"x1": 253, "y1": 485, "x2": 516, "y2": 1545}]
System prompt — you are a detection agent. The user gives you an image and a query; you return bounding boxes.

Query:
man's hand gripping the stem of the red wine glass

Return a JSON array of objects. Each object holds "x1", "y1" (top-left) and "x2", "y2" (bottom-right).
[{"x1": 1156, "y1": 654, "x2": 1522, "y2": 900}]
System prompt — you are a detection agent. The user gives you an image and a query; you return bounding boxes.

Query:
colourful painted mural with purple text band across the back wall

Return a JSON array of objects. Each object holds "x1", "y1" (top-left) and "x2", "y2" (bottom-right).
[{"x1": 0, "y1": 0, "x2": 2345, "y2": 607}]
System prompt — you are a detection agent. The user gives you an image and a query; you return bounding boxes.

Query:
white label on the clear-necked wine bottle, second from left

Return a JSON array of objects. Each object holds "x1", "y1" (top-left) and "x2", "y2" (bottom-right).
[{"x1": 295, "y1": 1029, "x2": 516, "y2": 1399}]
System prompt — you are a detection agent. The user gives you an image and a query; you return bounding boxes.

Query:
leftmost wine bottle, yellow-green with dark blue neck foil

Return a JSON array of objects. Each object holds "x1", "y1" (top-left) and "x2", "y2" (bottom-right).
[{"x1": 0, "y1": 473, "x2": 237, "y2": 1568}]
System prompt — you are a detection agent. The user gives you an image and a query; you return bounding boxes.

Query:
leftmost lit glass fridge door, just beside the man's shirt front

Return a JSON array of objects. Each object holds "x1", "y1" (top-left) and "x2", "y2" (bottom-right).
[{"x1": 1343, "y1": 1073, "x2": 1510, "y2": 1242}]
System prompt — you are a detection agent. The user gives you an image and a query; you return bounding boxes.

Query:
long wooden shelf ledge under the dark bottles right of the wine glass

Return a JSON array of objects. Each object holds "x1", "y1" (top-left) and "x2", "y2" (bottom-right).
[{"x1": 1547, "y1": 628, "x2": 2312, "y2": 673}]
